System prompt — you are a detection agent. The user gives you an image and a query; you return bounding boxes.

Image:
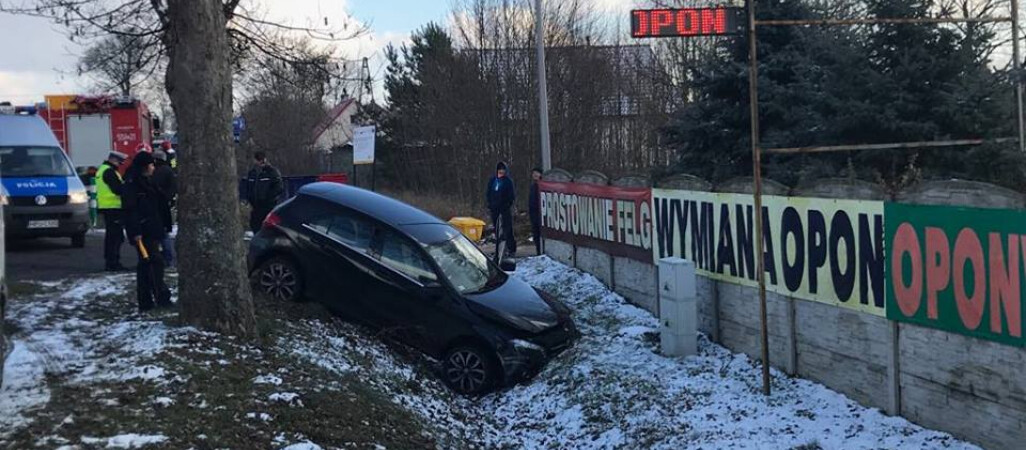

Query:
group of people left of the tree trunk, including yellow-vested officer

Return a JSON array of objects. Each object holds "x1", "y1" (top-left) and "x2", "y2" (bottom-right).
[{"x1": 95, "y1": 144, "x2": 177, "y2": 312}]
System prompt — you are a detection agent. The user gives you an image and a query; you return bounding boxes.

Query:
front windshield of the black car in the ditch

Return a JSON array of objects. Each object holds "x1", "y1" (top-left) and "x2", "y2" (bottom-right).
[{"x1": 427, "y1": 235, "x2": 506, "y2": 294}]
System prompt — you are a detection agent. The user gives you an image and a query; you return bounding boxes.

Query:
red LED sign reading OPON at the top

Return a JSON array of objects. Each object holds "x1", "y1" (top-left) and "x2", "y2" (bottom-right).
[{"x1": 631, "y1": 7, "x2": 745, "y2": 38}]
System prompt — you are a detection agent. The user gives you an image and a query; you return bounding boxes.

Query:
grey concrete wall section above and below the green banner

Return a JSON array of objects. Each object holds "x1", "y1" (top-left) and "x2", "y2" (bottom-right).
[{"x1": 897, "y1": 180, "x2": 1026, "y2": 449}]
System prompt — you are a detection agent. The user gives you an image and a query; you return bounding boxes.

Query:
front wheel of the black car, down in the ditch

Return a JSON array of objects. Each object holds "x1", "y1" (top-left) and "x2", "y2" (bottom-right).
[{"x1": 441, "y1": 345, "x2": 499, "y2": 396}]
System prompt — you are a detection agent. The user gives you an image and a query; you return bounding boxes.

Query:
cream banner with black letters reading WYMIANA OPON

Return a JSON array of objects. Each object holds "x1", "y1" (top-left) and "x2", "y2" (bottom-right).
[{"x1": 653, "y1": 189, "x2": 885, "y2": 316}]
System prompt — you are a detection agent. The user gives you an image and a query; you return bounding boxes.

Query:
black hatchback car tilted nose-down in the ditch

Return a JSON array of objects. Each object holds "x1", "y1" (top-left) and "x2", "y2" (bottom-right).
[{"x1": 248, "y1": 182, "x2": 578, "y2": 395}]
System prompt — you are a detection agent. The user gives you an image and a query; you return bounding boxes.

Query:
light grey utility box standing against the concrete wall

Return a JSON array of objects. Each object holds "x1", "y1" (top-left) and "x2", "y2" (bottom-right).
[{"x1": 659, "y1": 257, "x2": 699, "y2": 357}]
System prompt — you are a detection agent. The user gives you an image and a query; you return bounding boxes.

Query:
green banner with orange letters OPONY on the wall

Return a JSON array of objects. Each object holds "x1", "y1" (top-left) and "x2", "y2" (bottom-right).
[{"x1": 884, "y1": 203, "x2": 1026, "y2": 346}]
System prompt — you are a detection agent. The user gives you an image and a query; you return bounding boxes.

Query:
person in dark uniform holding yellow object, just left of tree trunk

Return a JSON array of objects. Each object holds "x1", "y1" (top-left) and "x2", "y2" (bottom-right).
[{"x1": 121, "y1": 152, "x2": 173, "y2": 312}]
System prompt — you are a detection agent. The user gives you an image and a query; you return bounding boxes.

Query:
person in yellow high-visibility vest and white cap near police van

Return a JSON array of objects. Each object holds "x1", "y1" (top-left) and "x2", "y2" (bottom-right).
[{"x1": 96, "y1": 152, "x2": 128, "y2": 272}]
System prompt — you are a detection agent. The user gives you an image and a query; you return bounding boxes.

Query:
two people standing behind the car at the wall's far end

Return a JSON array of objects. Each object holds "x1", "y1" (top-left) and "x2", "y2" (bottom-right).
[{"x1": 485, "y1": 162, "x2": 543, "y2": 256}]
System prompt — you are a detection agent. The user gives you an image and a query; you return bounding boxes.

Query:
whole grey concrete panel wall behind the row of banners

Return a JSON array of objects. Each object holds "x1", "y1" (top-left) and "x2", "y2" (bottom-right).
[{"x1": 546, "y1": 171, "x2": 1026, "y2": 449}]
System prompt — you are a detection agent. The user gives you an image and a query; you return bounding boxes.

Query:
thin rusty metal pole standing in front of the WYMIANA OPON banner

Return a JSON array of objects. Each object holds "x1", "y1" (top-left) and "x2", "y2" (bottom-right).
[{"x1": 745, "y1": 0, "x2": 770, "y2": 396}]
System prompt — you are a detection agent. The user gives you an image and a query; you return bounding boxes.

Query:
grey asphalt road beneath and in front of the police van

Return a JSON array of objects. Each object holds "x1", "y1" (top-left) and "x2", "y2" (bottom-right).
[{"x1": 6, "y1": 233, "x2": 135, "y2": 281}]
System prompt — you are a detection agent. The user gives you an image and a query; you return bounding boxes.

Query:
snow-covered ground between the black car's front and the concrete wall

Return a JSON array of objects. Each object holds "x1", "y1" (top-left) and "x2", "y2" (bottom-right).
[{"x1": 476, "y1": 257, "x2": 975, "y2": 449}]
